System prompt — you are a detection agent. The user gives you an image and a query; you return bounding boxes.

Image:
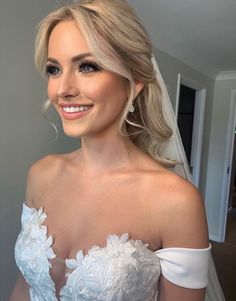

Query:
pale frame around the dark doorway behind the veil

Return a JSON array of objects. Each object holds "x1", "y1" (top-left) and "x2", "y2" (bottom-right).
[{"x1": 175, "y1": 73, "x2": 206, "y2": 188}]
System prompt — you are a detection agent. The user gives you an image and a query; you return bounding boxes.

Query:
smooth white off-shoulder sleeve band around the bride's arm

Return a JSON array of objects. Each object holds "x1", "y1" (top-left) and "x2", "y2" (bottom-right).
[{"x1": 155, "y1": 245, "x2": 211, "y2": 289}]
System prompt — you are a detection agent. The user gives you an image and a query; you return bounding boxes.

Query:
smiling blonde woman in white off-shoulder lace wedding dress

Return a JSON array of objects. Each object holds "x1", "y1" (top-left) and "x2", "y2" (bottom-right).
[{"x1": 11, "y1": 0, "x2": 210, "y2": 301}]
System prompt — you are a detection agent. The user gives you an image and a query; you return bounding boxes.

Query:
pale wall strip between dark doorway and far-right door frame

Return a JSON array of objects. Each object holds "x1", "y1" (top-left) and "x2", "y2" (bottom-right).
[{"x1": 206, "y1": 78, "x2": 236, "y2": 240}]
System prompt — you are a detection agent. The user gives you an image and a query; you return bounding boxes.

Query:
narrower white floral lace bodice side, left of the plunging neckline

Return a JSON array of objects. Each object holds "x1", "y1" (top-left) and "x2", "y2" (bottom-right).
[{"x1": 15, "y1": 208, "x2": 57, "y2": 301}]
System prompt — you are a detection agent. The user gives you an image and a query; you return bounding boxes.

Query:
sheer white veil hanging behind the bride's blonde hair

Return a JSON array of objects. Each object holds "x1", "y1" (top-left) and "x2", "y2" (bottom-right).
[{"x1": 152, "y1": 57, "x2": 225, "y2": 301}]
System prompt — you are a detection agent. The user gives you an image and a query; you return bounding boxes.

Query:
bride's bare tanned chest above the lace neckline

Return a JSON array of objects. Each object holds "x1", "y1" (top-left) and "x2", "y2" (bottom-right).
[{"x1": 34, "y1": 173, "x2": 159, "y2": 289}]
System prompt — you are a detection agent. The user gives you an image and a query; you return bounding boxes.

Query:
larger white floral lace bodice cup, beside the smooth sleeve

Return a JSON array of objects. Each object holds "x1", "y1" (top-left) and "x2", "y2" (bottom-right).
[{"x1": 61, "y1": 233, "x2": 160, "y2": 301}]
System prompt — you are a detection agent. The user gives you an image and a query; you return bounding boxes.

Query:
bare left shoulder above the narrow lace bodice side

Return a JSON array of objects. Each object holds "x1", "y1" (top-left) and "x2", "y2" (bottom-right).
[{"x1": 25, "y1": 154, "x2": 70, "y2": 208}]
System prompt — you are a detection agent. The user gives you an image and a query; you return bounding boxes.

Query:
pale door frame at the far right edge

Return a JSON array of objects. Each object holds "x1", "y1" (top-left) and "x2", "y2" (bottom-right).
[{"x1": 219, "y1": 90, "x2": 236, "y2": 242}]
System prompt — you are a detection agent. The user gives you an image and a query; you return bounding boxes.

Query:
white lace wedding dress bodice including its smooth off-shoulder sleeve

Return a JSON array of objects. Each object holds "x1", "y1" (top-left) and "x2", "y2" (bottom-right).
[{"x1": 15, "y1": 204, "x2": 210, "y2": 301}]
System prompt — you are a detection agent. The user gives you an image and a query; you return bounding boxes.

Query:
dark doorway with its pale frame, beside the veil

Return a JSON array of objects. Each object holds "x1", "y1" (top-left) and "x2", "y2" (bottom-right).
[{"x1": 175, "y1": 74, "x2": 206, "y2": 187}]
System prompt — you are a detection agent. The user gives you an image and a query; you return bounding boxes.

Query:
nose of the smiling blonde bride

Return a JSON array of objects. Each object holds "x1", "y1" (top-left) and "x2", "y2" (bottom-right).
[{"x1": 57, "y1": 73, "x2": 79, "y2": 98}]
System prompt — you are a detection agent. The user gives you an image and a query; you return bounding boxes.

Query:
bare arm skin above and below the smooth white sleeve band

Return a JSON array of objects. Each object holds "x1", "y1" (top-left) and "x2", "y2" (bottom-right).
[{"x1": 155, "y1": 172, "x2": 209, "y2": 301}]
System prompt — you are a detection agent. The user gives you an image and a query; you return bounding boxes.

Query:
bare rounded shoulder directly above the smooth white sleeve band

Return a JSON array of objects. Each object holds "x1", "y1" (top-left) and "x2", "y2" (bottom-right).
[{"x1": 148, "y1": 170, "x2": 208, "y2": 248}]
